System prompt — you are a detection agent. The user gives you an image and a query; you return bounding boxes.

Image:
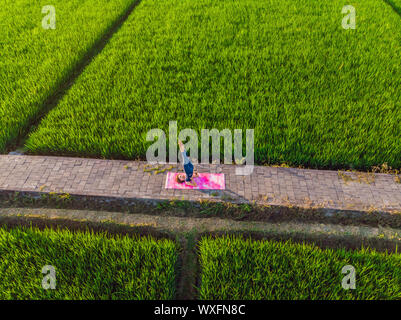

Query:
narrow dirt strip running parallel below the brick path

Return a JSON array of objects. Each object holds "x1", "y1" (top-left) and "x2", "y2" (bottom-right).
[{"x1": 0, "y1": 208, "x2": 401, "y2": 242}]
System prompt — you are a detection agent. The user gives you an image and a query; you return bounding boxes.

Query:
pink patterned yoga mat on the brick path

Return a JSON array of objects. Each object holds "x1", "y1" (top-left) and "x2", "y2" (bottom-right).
[{"x1": 166, "y1": 172, "x2": 226, "y2": 190}]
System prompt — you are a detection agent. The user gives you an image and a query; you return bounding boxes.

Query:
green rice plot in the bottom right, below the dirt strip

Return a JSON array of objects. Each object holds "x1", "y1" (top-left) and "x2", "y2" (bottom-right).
[{"x1": 199, "y1": 237, "x2": 401, "y2": 300}]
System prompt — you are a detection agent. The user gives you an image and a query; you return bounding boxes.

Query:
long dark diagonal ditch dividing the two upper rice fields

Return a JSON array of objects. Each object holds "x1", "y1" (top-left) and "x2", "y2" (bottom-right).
[{"x1": 7, "y1": 0, "x2": 141, "y2": 154}]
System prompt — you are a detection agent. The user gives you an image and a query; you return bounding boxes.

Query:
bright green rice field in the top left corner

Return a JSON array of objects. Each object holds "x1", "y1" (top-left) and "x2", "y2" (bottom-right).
[{"x1": 0, "y1": 0, "x2": 134, "y2": 152}]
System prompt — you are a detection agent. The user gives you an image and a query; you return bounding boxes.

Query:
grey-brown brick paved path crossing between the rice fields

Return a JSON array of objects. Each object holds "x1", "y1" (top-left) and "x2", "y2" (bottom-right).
[{"x1": 0, "y1": 155, "x2": 401, "y2": 212}]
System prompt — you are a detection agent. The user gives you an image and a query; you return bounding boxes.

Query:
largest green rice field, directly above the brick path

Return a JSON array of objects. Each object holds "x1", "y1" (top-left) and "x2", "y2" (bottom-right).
[{"x1": 27, "y1": 0, "x2": 401, "y2": 168}]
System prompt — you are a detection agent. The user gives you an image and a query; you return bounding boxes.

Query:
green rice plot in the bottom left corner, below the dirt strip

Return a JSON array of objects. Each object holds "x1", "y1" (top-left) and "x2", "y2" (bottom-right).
[{"x1": 0, "y1": 228, "x2": 177, "y2": 300}]
